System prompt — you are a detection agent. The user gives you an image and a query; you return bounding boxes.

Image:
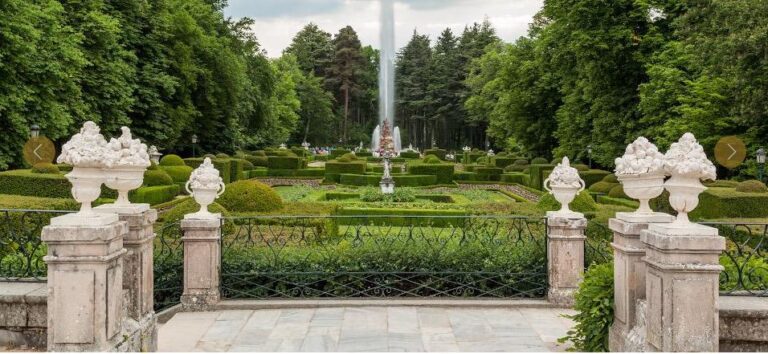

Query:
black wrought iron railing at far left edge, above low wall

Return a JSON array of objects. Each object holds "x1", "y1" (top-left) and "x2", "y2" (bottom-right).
[{"x1": 0, "y1": 209, "x2": 71, "y2": 281}]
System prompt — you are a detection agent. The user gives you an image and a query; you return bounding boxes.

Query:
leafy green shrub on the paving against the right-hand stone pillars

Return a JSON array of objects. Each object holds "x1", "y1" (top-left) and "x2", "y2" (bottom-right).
[{"x1": 559, "y1": 262, "x2": 613, "y2": 352}]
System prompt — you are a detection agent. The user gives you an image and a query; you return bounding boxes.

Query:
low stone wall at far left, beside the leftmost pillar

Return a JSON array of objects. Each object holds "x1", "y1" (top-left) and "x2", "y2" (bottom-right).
[{"x1": 0, "y1": 282, "x2": 48, "y2": 350}]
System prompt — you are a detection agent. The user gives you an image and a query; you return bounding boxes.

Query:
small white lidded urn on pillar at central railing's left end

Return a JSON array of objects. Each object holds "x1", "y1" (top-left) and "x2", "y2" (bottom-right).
[{"x1": 184, "y1": 157, "x2": 226, "y2": 219}]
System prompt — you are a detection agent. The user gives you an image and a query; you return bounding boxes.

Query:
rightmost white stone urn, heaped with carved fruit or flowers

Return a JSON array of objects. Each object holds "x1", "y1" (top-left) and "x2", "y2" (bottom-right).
[{"x1": 664, "y1": 133, "x2": 717, "y2": 226}]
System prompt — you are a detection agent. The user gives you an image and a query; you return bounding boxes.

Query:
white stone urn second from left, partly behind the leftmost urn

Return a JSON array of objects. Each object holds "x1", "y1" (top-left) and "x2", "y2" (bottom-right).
[{"x1": 105, "y1": 127, "x2": 151, "y2": 206}]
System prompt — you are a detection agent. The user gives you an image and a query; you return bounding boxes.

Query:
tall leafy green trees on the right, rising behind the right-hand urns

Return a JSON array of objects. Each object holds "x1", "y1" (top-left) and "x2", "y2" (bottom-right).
[{"x1": 465, "y1": 0, "x2": 768, "y2": 174}]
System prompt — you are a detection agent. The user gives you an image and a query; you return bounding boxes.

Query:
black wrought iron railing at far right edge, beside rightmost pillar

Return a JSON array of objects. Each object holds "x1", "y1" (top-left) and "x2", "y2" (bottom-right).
[{"x1": 703, "y1": 222, "x2": 768, "y2": 296}]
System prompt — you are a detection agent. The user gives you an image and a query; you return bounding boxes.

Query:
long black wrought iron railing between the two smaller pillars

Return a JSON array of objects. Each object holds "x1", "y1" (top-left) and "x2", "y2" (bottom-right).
[{"x1": 221, "y1": 215, "x2": 547, "y2": 298}]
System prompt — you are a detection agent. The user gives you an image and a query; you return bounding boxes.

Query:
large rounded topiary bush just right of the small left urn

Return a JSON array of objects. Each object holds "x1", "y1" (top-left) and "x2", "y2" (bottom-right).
[{"x1": 218, "y1": 180, "x2": 283, "y2": 212}]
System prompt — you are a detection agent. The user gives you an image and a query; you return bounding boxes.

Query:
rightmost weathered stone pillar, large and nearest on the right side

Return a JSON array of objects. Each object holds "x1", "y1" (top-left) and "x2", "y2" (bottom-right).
[{"x1": 640, "y1": 223, "x2": 725, "y2": 352}]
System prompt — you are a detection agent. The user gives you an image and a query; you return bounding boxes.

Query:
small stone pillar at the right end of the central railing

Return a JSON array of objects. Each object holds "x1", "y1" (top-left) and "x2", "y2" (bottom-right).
[{"x1": 547, "y1": 214, "x2": 587, "y2": 306}]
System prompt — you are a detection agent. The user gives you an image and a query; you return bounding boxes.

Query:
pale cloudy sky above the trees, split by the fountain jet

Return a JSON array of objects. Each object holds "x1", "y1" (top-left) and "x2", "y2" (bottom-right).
[{"x1": 225, "y1": 0, "x2": 543, "y2": 57}]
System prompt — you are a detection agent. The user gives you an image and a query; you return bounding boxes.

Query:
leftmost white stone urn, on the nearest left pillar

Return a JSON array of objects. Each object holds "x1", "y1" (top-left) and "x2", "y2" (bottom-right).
[{"x1": 56, "y1": 121, "x2": 113, "y2": 217}]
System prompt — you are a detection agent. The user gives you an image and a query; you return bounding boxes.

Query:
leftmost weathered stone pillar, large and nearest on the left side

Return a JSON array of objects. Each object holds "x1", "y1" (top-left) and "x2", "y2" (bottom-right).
[{"x1": 41, "y1": 214, "x2": 128, "y2": 352}]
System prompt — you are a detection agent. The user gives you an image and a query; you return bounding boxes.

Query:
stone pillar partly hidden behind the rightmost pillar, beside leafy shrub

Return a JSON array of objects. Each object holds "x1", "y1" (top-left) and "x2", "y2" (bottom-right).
[{"x1": 608, "y1": 213, "x2": 674, "y2": 352}]
